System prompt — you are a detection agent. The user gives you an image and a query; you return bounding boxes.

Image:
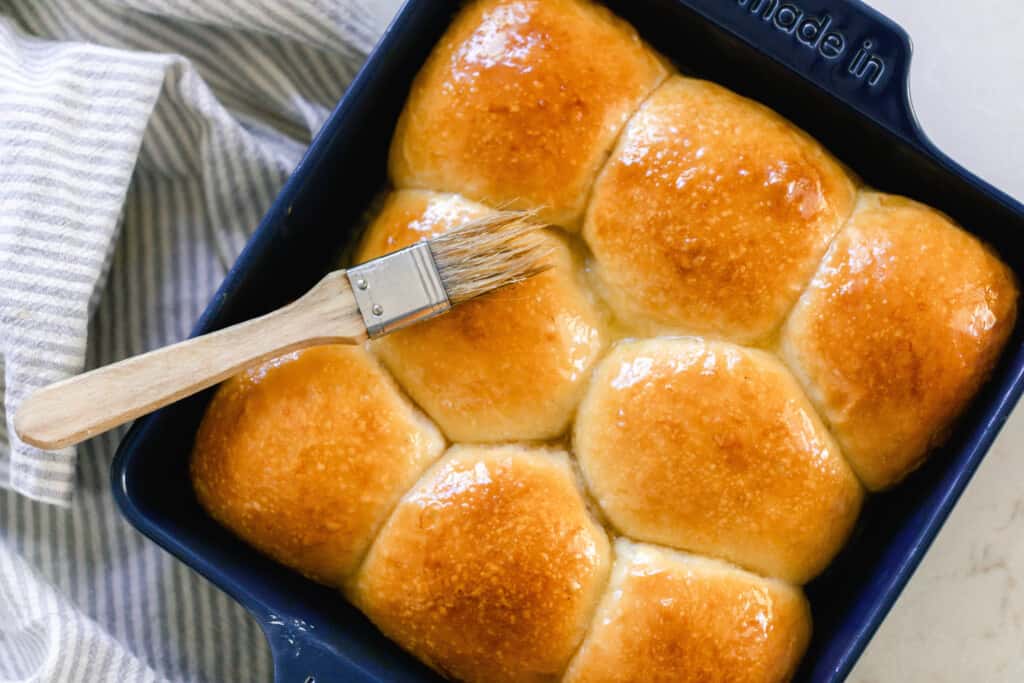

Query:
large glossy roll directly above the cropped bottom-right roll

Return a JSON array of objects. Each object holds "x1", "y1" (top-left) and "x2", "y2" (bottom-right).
[{"x1": 574, "y1": 338, "x2": 862, "y2": 583}]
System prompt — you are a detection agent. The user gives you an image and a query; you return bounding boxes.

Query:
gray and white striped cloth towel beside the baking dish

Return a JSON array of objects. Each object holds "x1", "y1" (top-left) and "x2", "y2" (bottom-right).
[{"x1": 0, "y1": 0, "x2": 398, "y2": 683}]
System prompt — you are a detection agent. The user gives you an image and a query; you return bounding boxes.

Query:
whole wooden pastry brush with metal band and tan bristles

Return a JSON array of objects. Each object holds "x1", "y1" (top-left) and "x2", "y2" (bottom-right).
[{"x1": 14, "y1": 211, "x2": 549, "y2": 450}]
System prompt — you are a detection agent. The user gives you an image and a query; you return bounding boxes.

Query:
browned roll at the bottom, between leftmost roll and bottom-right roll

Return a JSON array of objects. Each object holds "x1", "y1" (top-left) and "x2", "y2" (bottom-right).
[{"x1": 351, "y1": 446, "x2": 609, "y2": 683}]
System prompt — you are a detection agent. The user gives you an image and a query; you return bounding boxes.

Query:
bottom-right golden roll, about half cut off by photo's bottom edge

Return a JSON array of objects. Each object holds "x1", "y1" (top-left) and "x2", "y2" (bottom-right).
[{"x1": 562, "y1": 540, "x2": 811, "y2": 683}]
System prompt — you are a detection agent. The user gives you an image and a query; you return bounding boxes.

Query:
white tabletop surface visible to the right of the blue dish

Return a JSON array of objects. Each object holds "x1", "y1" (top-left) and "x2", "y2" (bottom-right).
[{"x1": 370, "y1": 0, "x2": 1024, "y2": 683}]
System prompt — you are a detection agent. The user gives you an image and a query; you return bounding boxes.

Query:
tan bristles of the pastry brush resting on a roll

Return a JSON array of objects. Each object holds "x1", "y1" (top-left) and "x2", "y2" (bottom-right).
[{"x1": 430, "y1": 211, "x2": 551, "y2": 305}]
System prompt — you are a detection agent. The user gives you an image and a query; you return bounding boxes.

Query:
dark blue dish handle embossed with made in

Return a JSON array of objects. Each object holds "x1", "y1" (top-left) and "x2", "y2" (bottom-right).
[{"x1": 682, "y1": 0, "x2": 929, "y2": 146}]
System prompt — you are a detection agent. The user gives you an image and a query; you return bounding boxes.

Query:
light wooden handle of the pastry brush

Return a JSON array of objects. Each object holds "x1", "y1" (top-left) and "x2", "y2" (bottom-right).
[{"x1": 14, "y1": 271, "x2": 366, "y2": 451}]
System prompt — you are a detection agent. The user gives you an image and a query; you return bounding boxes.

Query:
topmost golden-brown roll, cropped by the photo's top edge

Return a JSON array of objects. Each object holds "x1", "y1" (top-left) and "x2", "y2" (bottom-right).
[{"x1": 390, "y1": 0, "x2": 668, "y2": 227}]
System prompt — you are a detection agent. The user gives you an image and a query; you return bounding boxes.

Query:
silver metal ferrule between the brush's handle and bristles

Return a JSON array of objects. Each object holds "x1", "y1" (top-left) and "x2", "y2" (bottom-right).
[{"x1": 348, "y1": 242, "x2": 452, "y2": 339}]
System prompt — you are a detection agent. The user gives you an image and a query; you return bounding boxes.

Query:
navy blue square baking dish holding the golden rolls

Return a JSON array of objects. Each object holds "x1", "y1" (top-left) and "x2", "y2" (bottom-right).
[{"x1": 112, "y1": 0, "x2": 1024, "y2": 683}]
